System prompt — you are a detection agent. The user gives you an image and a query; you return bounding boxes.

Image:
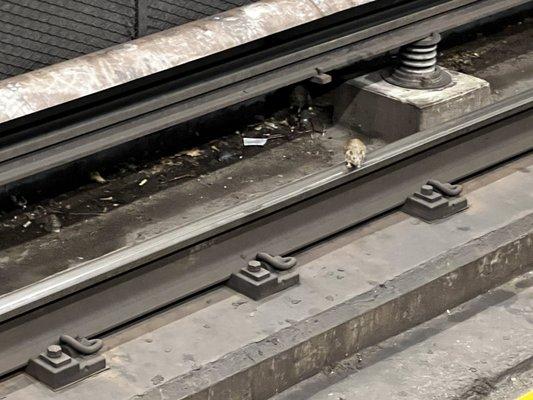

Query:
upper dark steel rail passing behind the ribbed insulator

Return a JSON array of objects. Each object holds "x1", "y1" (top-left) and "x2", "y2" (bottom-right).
[{"x1": 0, "y1": 0, "x2": 531, "y2": 187}]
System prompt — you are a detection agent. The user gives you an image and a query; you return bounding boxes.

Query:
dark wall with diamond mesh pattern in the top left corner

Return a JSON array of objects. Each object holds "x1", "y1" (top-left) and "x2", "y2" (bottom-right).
[{"x1": 0, "y1": 0, "x2": 257, "y2": 79}]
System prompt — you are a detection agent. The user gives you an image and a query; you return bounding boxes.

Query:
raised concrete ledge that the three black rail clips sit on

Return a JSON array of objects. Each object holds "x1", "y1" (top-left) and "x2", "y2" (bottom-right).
[{"x1": 0, "y1": 156, "x2": 533, "y2": 400}]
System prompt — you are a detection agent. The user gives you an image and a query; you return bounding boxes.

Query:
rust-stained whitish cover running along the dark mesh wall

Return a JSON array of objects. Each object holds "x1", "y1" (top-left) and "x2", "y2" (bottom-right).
[{"x1": 0, "y1": 0, "x2": 375, "y2": 123}]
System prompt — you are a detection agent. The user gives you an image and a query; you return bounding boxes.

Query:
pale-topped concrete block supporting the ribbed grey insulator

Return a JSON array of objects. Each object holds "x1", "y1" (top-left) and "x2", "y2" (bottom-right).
[{"x1": 335, "y1": 71, "x2": 491, "y2": 142}]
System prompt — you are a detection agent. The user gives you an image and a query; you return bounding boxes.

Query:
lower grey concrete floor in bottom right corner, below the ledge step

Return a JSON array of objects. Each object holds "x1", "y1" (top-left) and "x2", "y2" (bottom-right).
[{"x1": 272, "y1": 272, "x2": 533, "y2": 400}]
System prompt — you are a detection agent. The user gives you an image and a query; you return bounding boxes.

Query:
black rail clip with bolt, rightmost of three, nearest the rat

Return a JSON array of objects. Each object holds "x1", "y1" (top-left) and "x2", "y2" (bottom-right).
[{"x1": 403, "y1": 179, "x2": 468, "y2": 222}]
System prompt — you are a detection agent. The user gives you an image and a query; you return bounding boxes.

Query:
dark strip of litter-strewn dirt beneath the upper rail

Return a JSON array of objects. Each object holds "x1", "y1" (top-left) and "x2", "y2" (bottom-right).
[{"x1": 0, "y1": 91, "x2": 330, "y2": 250}]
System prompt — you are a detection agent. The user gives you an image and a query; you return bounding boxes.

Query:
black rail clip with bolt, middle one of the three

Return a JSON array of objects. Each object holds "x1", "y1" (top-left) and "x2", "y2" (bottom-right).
[{"x1": 228, "y1": 253, "x2": 300, "y2": 300}]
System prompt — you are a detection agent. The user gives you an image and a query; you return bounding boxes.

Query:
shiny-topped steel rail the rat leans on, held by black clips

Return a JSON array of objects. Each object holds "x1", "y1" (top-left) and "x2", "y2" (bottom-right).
[{"x1": 0, "y1": 90, "x2": 533, "y2": 374}]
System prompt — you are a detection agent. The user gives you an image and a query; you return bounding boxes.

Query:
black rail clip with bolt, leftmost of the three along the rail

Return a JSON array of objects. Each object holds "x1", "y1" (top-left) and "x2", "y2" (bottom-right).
[{"x1": 26, "y1": 335, "x2": 106, "y2": 390}]
